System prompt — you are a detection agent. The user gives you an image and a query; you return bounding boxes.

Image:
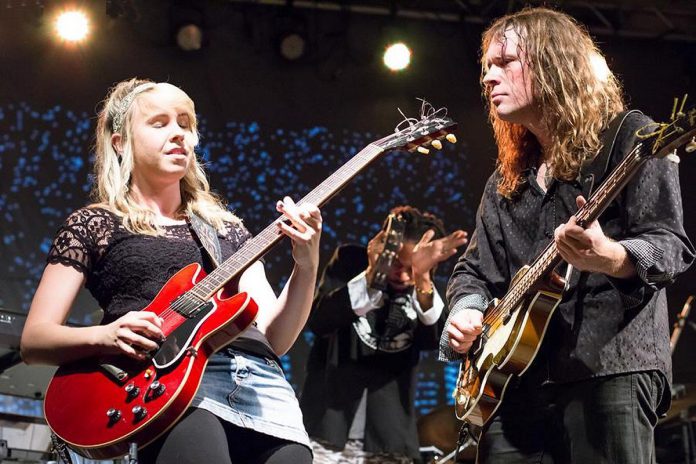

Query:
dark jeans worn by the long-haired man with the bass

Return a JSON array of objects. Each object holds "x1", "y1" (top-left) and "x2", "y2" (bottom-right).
[{"x1": 478, "y1": 371, "x2": 669, "y2": 464}]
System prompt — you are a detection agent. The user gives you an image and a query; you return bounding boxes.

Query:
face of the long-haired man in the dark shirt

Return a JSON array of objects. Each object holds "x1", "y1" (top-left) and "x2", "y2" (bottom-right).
[{"x1": 483, "y1": 29, "x2": 538, "y2": 127}]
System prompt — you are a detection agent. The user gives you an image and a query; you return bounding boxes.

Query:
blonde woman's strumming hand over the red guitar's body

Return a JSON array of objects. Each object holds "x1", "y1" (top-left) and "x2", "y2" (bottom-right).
[{"x1": 101, "y1": 311, "x2": 164, "y2": 360}]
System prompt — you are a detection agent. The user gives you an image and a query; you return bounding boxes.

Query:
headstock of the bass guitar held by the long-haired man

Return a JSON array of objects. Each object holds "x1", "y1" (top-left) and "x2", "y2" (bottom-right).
[{"x1": 637, "y1": 95, "x2": 696, "y2": 162}]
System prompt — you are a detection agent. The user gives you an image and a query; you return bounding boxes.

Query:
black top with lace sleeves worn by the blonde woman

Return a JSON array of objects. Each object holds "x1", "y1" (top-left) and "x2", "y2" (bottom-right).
[{"x1": 48, "y1": 207, "x2": 270, "y2": 353}]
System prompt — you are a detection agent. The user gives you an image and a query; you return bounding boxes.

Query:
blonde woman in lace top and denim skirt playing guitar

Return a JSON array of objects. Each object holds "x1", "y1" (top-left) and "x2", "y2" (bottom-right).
[{"x1": 21, "y1": 79, "x2": 322, "y2": 464}]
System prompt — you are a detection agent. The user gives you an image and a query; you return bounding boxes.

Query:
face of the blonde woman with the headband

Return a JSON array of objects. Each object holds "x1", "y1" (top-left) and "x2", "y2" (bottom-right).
[{"x1": 131, "y1": 84, "x2": 197, "y2": 188}]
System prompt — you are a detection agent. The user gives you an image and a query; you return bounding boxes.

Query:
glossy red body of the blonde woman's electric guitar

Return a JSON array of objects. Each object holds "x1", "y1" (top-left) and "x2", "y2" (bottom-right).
[{"x1": 44, "y1": 264, "x2": 258, "y2": 459}]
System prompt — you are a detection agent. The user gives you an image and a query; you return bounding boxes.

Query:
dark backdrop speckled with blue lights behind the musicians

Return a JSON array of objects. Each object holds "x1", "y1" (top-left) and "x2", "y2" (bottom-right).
[{"x1": 0, "y1": 102, "x2": 472, "y2": 412}]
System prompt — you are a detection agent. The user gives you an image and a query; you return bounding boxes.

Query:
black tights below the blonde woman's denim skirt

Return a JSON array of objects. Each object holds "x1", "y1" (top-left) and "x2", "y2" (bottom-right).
[{"x1": 138, "y1": 408, "x2": 312, "y2": 464}]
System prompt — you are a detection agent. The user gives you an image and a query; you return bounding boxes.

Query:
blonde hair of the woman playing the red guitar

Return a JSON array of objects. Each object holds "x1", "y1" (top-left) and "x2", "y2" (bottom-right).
[{"x1": 92, "y1": 78, "x2": 240, "y2": 235}]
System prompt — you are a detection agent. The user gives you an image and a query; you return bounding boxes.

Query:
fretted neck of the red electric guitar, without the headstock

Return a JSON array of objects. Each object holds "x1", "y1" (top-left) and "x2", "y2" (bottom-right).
[{"x1": 190, "y1": 144, "x2": 384, "y2": 300}]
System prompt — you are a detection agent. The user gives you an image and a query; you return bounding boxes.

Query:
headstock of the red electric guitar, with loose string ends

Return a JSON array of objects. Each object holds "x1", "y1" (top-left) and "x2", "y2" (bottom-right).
[{"x1": 373, "y1": 102, "x2": 457, "y2": 154}]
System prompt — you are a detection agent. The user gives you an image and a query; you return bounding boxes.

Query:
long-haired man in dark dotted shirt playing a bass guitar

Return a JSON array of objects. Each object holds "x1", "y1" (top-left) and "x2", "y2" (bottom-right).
[{"x1": 440, "y1": 8, "x2": 694, "y2": 464}]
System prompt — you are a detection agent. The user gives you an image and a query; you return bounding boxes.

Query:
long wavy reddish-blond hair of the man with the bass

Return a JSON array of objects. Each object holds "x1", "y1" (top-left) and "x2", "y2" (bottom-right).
[{"x1": 481, "y1": 8, "x2": 624, "y2": 198}]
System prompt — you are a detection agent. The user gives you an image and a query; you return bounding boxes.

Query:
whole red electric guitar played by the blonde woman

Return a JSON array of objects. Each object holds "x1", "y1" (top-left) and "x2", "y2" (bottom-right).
[{"x1": 44, "y1": 110, "x2": 456, "y2": 459}]
